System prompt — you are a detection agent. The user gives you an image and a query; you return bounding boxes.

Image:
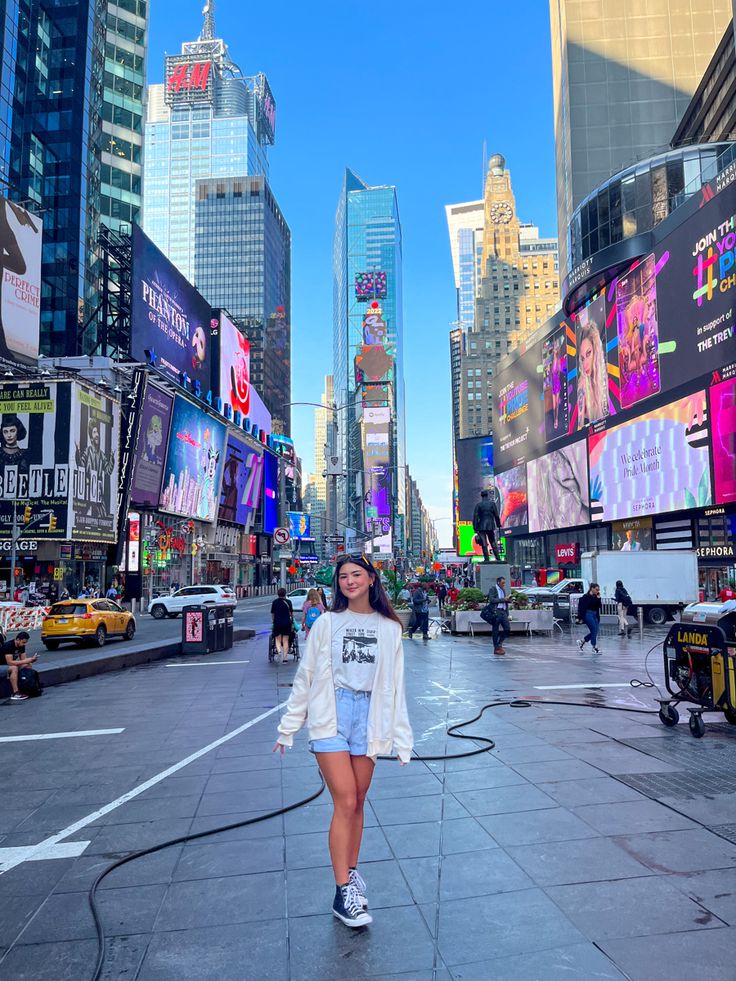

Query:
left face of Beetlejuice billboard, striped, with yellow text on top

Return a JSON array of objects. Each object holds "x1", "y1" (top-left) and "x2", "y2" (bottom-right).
[{"x1": 0, "y1": 383, "x2": 74, "y2": 539}]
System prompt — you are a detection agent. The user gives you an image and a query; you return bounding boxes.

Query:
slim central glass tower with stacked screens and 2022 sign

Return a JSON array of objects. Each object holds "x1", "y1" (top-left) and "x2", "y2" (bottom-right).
[{"x1": 333, "y1": 170, "x2": 406, "y2": 557}]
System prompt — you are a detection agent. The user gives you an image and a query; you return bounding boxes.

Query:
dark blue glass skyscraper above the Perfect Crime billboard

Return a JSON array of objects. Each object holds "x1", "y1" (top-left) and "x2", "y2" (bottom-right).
[{"x1": 0, "y1": 0, "x2": 106, "y2": 356}]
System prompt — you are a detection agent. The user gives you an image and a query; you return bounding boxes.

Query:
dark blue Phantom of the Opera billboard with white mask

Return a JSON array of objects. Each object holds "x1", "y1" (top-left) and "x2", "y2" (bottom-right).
[{"x1": 130, "y1": 225, "x2": 211, "y2": 386}]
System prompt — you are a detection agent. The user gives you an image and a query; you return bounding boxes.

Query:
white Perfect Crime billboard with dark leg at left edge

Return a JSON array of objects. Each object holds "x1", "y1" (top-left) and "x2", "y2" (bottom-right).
[{"x1": 0, "y1": 195, "x2": 43, "y2": 360}]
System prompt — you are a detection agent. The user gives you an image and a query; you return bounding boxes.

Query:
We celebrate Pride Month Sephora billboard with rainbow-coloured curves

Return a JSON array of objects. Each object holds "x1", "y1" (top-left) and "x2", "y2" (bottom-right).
[{"x1": 588, "y1": 391, "x2": 712, "y2": 521}]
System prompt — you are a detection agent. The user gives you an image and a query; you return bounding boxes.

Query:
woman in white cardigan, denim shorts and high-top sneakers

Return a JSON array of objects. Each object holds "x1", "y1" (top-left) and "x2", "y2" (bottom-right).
[{"x1": 274, "y1": 555, "x2": 413, "y2": 927}]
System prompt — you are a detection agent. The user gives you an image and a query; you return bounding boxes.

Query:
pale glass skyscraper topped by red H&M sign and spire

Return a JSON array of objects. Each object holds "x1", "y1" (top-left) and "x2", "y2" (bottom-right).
[{"x1": 143, "y1": 14, "x2": 275, "y2": 284}]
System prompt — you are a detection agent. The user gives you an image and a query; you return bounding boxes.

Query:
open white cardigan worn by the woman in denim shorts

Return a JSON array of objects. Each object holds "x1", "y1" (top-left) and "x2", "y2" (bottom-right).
[{"x1": 278, "y1": 613, "x2": 414, "y2": 763}]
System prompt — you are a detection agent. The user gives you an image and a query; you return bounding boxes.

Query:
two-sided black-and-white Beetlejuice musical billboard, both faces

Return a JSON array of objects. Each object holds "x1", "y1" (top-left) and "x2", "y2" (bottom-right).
[{"x1": 0, "y1": 382, "x2": 120, "y2": 542}]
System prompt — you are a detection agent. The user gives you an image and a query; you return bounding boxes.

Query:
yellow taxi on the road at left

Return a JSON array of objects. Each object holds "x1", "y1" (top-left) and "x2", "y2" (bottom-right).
[{"x1": 41, "y1": 599, "x2": 135, "y2": 651}]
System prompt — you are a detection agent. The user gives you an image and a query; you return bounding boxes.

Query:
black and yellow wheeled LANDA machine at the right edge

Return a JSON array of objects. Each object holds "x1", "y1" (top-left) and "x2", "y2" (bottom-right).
[{"x1": 659, "y1": 600, "x2": 736, "y2": 738}]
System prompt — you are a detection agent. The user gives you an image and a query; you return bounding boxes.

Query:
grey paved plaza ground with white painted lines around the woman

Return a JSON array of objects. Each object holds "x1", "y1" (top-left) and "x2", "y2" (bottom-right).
[{"x1": 0, "y1": 632, "x2": 736, "y2": 981}]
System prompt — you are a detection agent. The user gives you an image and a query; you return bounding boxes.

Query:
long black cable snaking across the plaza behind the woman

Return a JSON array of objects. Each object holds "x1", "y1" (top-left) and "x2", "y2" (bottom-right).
[{"x1": 88, "y1": 686, "x2": 668, "y2": 981}]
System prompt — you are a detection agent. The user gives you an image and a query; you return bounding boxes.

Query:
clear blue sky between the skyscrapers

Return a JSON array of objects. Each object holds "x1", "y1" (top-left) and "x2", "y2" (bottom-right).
[{"x1": 148, "y1": 0, "x2": 556, "y2": 544}]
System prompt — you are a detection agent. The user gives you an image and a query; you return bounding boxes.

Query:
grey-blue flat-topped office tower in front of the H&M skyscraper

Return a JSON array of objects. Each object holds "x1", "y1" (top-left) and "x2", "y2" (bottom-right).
[{"x1": 194, "y1": 177, "x2": 291, "y2": 435}]
